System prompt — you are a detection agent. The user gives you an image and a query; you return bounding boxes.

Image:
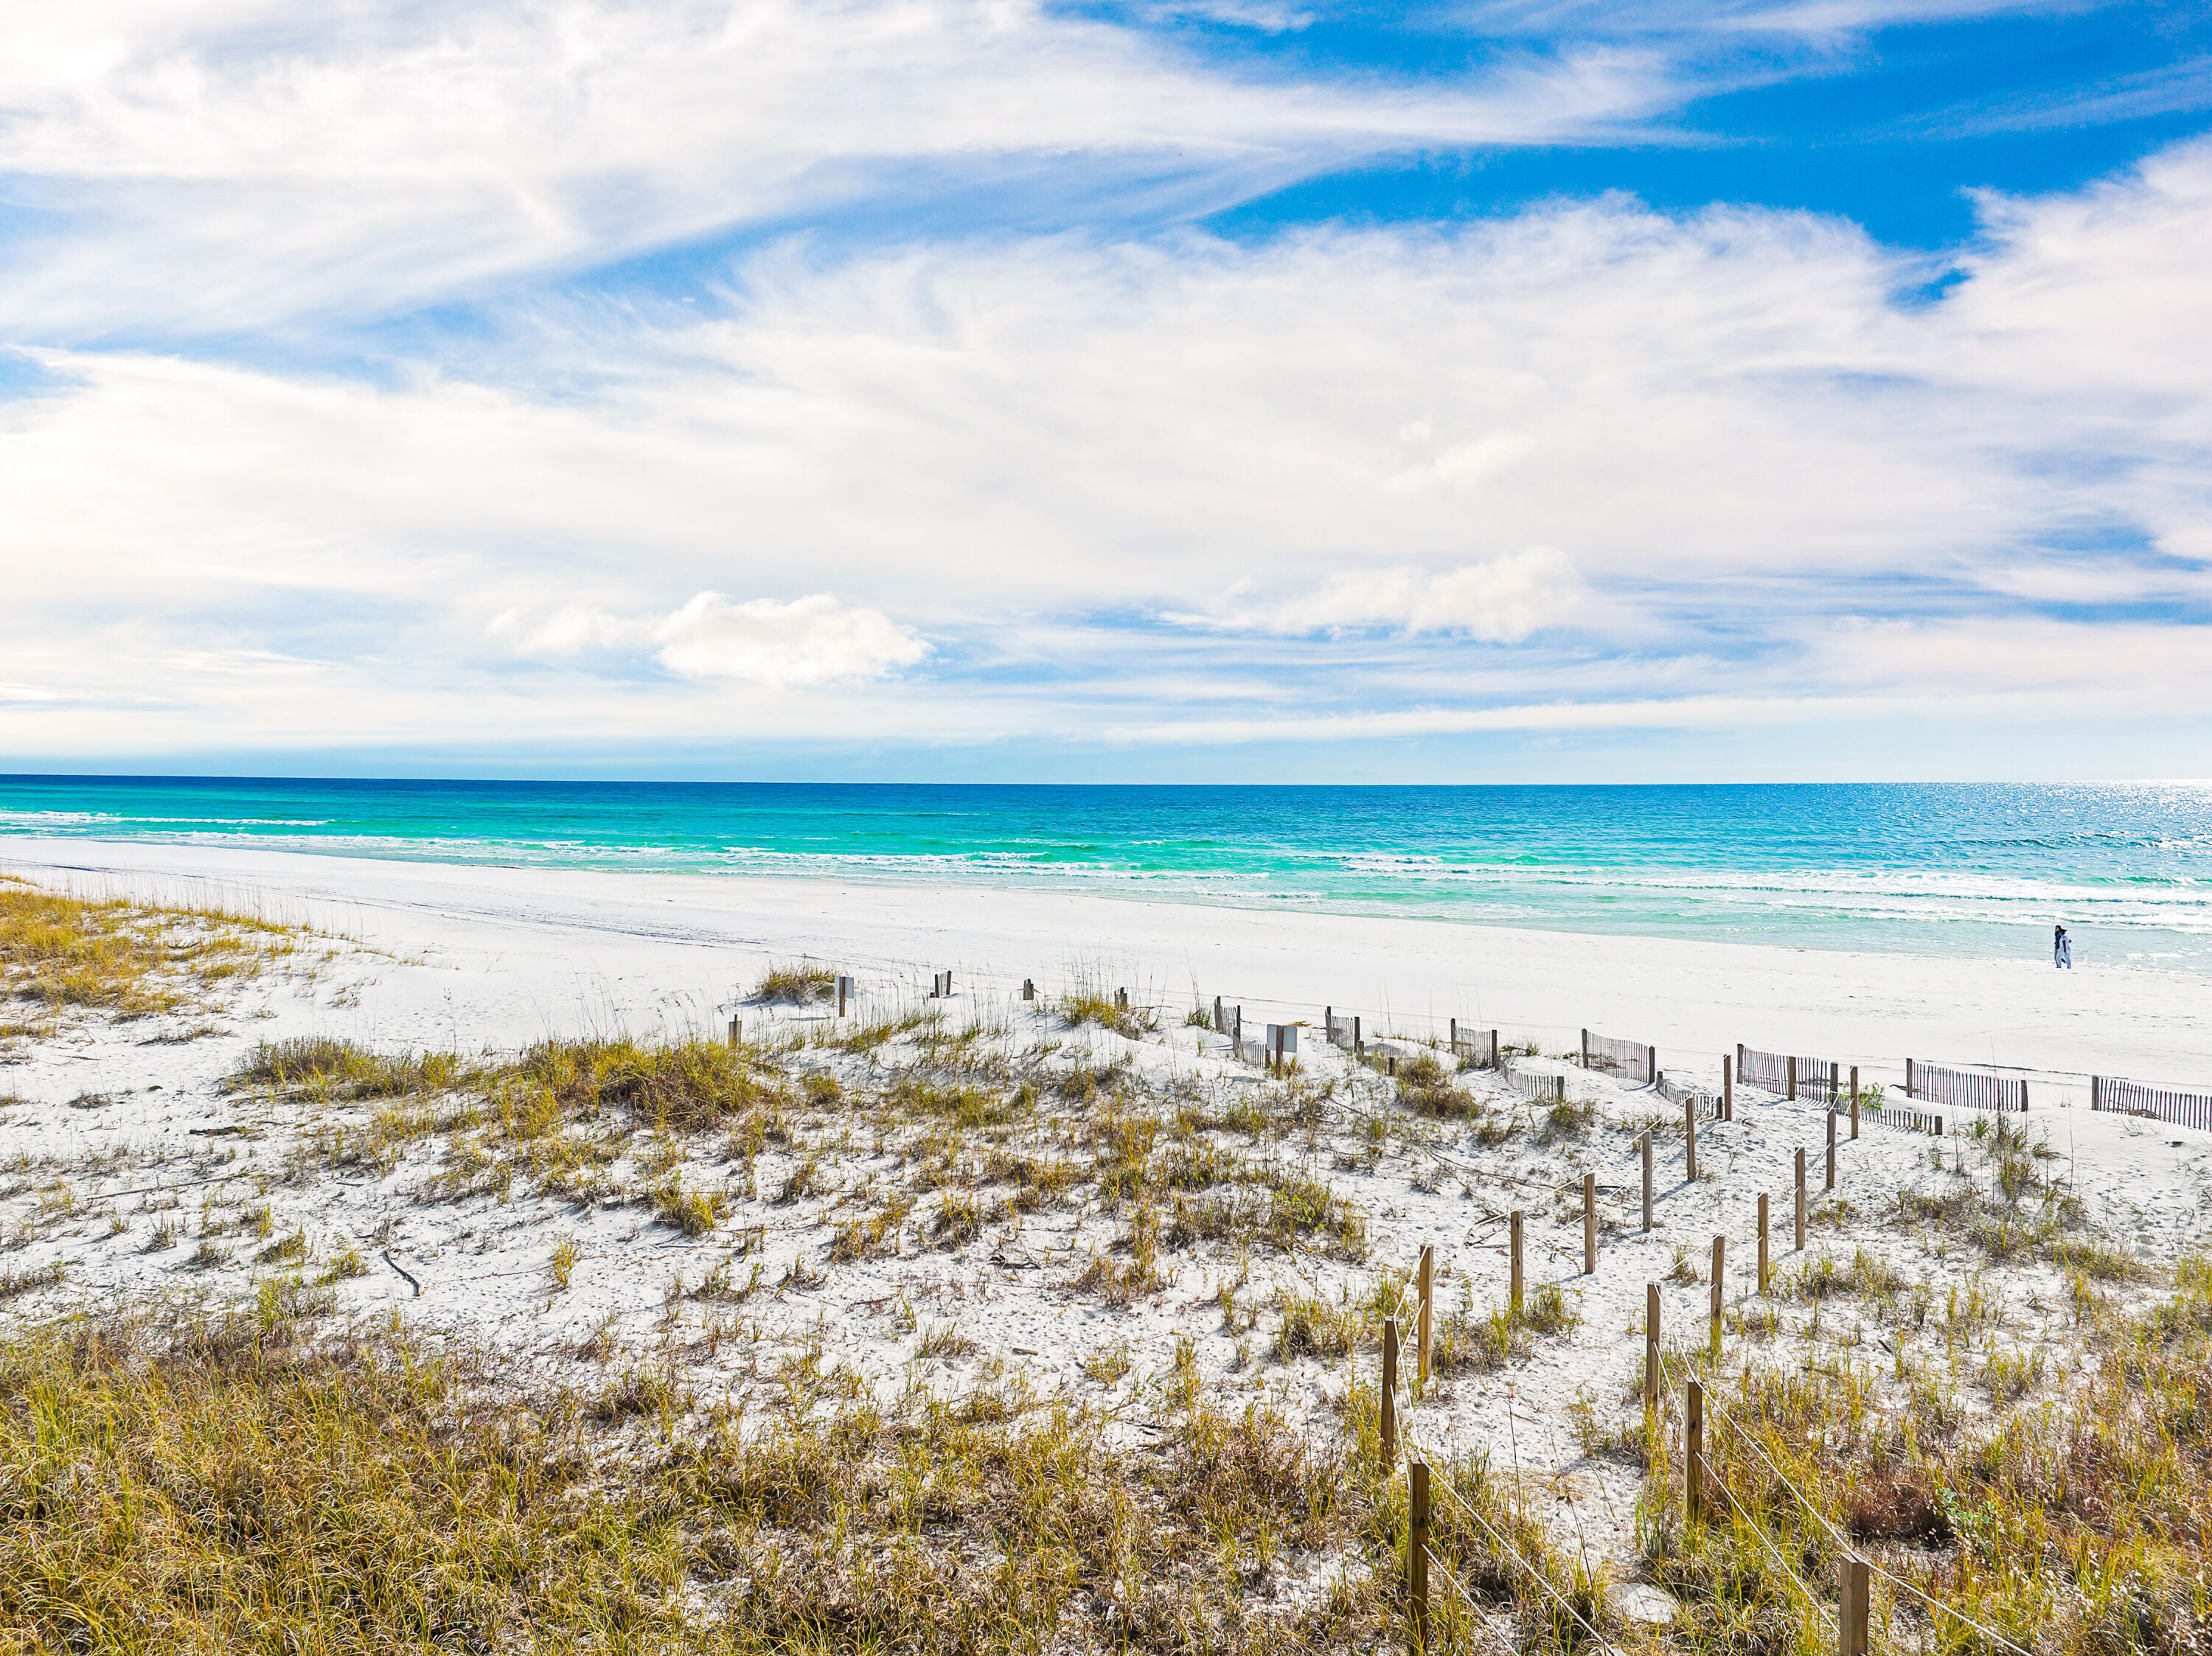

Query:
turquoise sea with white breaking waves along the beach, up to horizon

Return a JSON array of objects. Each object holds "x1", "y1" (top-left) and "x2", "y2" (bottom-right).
[{"x1": 0, "y1": 776, "x2": 2212, "y2": 970}]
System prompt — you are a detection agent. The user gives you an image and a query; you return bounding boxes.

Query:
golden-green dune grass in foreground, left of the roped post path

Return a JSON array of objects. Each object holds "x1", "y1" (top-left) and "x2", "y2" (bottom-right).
[{"x1": 0, "y1": 1291, "x2": 1511, "y2": 1654}]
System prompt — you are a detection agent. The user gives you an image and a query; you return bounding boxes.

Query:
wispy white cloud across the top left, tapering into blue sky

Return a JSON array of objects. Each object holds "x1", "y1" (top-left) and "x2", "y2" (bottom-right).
[{"x1": 0, "y1": 0, "x2": 1677, "y2": 338}]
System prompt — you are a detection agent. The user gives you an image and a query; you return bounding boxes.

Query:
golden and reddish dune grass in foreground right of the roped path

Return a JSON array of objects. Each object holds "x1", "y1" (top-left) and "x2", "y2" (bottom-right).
[{"x1": 1639, "y1": 1260, "x2": 2212, "y2": 1656}]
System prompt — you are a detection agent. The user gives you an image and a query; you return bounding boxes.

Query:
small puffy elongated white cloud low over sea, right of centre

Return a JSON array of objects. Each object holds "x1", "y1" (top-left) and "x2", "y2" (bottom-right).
[{"x1": 1175, "y1": 546, "x2": 1582, "y2": 644}]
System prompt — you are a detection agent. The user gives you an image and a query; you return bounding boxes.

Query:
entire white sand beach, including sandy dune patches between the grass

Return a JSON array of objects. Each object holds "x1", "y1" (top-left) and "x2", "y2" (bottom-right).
[{"x1": 0, "y1": 840, "x2": 2212, "y2": 1636}]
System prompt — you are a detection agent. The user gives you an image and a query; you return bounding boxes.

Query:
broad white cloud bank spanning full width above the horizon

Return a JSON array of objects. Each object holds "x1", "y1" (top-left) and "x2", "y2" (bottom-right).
[{"x1": 0, "y1": 135, "x2": 2212, "y2": 763}]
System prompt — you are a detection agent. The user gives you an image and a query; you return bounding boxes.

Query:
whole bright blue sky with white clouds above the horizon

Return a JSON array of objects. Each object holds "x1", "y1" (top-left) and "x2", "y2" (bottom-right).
[{"x1": 0, "y1": 0, "x2": 2212, "y2": 783}]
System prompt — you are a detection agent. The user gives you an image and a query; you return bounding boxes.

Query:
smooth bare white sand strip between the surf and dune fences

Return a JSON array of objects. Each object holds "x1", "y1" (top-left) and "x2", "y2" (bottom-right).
[{"x1": 0, "y1": 838, "x2": 2212, "y2": 1103}]
